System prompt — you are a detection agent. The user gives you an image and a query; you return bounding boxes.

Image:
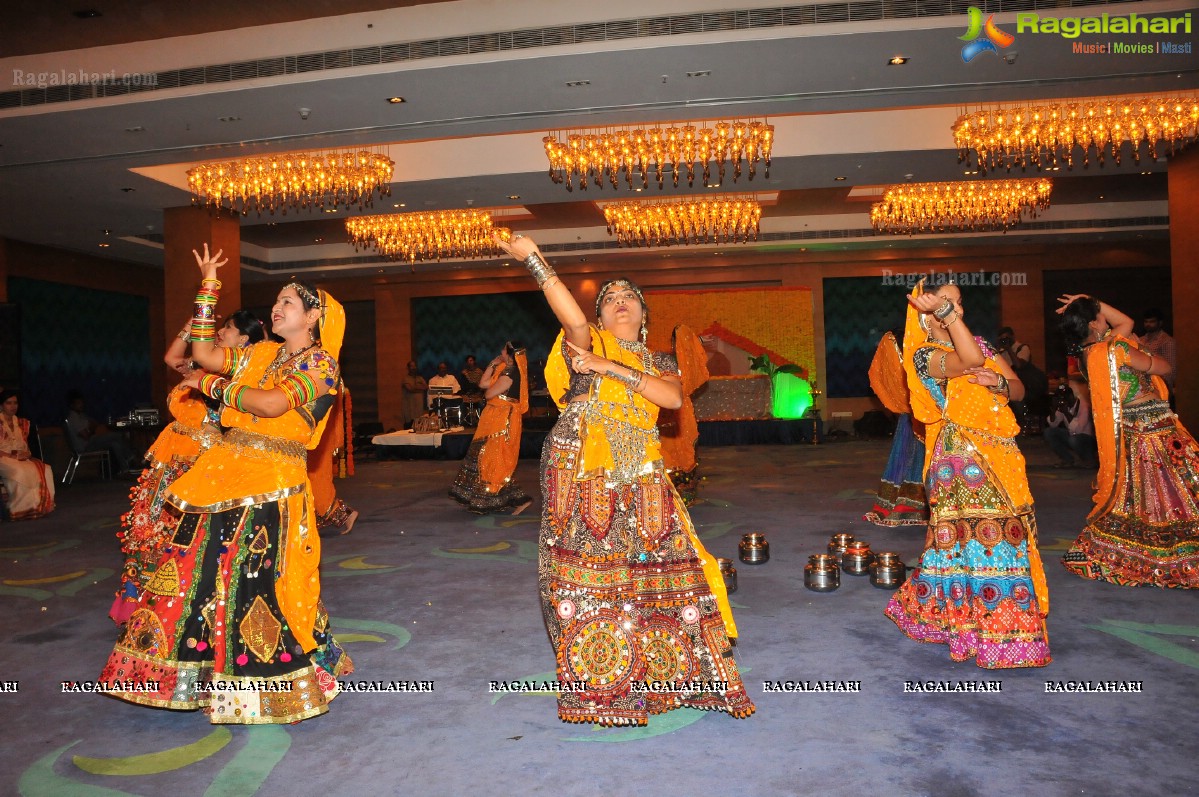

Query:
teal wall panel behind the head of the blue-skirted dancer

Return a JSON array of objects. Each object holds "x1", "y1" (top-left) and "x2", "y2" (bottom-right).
[{"x1": 824, "y1": 272, "x2": 1002, "y2": 398}]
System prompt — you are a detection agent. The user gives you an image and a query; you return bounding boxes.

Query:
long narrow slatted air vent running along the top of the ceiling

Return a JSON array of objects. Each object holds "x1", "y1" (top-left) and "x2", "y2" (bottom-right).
[{"x1": 0, "y1": 0, "x2": 1128, "y2": 108}]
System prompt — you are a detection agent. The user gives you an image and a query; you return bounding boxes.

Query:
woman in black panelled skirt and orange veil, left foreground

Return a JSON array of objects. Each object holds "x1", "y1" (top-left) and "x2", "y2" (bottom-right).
[{"x1": 101, "y1": 247, "x2": 351, "y2": 724}]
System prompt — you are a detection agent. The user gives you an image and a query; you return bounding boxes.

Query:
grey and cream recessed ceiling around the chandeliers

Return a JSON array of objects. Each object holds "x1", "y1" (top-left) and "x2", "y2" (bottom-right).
[{"x1": 0, "y1": 0, "x2": 1199, "y2": 280}]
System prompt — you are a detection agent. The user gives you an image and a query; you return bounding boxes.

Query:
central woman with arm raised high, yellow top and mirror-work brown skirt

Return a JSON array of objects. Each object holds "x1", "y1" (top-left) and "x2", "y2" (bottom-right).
[{"x1": 498, "y1": 235, "x2": 754, "y2": 725}]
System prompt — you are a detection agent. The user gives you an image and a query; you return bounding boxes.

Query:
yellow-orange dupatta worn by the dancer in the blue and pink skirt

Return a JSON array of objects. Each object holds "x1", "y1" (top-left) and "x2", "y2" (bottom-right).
[{"x1": 903, "y1": 280, "x2": 1049, "y2": 615}]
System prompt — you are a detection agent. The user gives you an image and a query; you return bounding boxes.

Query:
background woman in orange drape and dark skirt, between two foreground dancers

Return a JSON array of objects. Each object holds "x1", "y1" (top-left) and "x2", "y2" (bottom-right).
[{"x1": 450, "y1": 340, "x2": 532, "y2": 514}]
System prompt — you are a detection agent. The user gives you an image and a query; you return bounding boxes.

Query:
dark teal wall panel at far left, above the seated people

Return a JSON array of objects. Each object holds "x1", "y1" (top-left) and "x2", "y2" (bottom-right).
[{"x1": 8, "y1": 277, "x2": 152, "y2": 425}]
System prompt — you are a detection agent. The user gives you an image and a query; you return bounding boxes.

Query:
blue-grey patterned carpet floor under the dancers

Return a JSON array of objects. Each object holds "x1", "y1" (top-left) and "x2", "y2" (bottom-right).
[{"x1": 0, "y1": 441, "x2": 1199, "y2": 797}]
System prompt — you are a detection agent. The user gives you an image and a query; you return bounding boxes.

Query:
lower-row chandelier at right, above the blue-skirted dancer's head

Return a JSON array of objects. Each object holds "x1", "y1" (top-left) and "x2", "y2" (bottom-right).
[{"x1": 870, "y1": 177, "x2": 1053, "y2": 235}]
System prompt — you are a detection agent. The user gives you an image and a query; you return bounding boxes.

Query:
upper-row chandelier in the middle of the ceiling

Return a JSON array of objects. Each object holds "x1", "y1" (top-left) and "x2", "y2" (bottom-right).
[{"x1": 542, "y1": 120, "x2": 775, "y2": 191}]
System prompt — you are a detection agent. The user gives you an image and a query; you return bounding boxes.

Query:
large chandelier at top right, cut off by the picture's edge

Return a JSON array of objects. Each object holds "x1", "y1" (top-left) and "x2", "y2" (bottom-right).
[{"x1": 953, "y1": 96, "x2": 1199, "y2": 174}]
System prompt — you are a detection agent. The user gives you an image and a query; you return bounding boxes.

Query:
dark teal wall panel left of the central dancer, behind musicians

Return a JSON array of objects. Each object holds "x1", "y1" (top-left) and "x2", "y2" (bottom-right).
[{"x1": 410, "y1": 290, "x2": 561, "y2": 387}]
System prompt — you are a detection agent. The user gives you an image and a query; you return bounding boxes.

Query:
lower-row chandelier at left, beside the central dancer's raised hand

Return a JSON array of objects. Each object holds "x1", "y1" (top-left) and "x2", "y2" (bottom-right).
[{"x1": 345, "y1": 210, "x2": 511, "y2": 262}]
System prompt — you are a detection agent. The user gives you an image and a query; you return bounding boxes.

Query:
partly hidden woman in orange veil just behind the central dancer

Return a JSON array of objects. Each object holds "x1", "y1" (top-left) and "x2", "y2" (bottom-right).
[{"x1": 658, "y1": 324, "x2": 707, "y2": 506}]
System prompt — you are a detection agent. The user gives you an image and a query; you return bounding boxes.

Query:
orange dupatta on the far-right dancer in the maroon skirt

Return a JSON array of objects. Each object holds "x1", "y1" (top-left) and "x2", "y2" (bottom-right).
[{"x1": 1086, "y1": 333, "x2": 1169, "y2": 520}]
